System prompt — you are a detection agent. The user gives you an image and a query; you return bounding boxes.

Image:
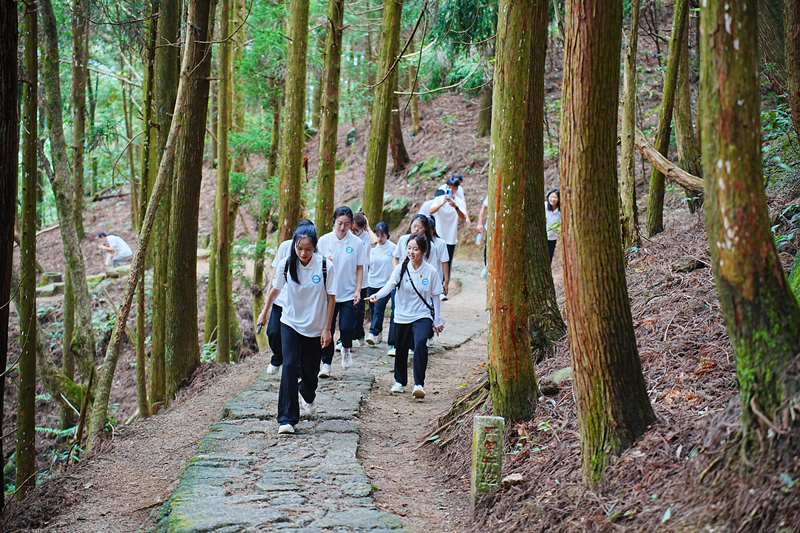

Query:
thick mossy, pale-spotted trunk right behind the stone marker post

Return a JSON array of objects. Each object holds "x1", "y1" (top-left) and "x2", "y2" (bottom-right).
[{"x1": 487, "y1": 0, "x2": 557, "y2": 420}]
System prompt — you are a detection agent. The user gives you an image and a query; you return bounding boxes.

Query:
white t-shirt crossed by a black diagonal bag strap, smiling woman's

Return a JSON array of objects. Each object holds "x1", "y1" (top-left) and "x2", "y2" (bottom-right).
[{"x1": 377, "y1": 261, "x2": 442, "y2": 325}]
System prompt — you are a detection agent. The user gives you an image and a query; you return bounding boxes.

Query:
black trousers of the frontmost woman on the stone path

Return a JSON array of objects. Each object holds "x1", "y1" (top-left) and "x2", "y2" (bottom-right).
[{"x1": 278, "y1": 324, "x2": 322, "y2": 425}]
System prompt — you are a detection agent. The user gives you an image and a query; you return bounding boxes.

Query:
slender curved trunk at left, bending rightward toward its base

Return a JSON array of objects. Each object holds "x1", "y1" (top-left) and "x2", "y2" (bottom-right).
[{"x1": 39, "y1": 0, "x2": 95, "y2": 382}]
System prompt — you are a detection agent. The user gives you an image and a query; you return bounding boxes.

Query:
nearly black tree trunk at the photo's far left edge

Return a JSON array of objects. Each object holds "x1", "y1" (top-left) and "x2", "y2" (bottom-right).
[{"x1": 0, "y1": 0, "x2": 17, "y2": 513}]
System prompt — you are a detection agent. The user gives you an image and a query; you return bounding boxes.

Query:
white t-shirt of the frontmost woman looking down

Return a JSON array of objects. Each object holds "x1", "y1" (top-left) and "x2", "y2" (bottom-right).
[{"x1": 272, "y1": 253, "x2": 336, "y2": 337}]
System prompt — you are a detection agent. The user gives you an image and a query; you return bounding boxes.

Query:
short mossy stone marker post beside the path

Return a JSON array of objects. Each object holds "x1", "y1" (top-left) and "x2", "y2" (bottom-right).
[{"x1": 469, "y1": 416, "x2": 506, "y2": 520}]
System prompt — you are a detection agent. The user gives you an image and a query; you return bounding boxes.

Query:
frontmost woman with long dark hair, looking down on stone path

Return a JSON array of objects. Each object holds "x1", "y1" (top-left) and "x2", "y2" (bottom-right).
[{"x1": 256, "y1": 225, "x2": 336, "y2": 433}]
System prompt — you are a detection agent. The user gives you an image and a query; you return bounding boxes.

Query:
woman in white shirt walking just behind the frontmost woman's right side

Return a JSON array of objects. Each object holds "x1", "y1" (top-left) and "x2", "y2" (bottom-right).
[{"x1": 317, "y1": 206, "x2": 367, "y2": 378}]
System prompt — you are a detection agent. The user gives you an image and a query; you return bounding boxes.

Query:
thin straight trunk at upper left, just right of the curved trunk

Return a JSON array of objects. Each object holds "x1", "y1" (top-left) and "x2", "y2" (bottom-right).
[{"x1": 70, "y1": 0, "x2": 89, "y2": 240}]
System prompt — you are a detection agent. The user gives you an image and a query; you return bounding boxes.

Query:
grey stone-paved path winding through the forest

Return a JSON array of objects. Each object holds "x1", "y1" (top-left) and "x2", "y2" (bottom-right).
[{"x1": 150, "y1": 263, "x2": 486, "y2": 533}]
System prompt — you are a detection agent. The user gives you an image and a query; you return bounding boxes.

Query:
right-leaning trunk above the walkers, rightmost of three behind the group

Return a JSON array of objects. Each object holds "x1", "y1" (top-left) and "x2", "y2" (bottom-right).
[{"x1": 363, "y1": 0, "x2": 403, "y2": 221}]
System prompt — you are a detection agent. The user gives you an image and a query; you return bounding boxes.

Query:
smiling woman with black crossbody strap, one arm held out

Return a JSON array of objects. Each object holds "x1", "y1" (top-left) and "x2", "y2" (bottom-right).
[{"x1": 369, "y1": 233, "x2": 444, "y2": 398}]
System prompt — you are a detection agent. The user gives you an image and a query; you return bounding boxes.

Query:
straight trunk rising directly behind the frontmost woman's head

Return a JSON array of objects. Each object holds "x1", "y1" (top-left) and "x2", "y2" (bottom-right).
[{"x1": 276, "y1": 0, "x2": 309, "y2": 241}]
